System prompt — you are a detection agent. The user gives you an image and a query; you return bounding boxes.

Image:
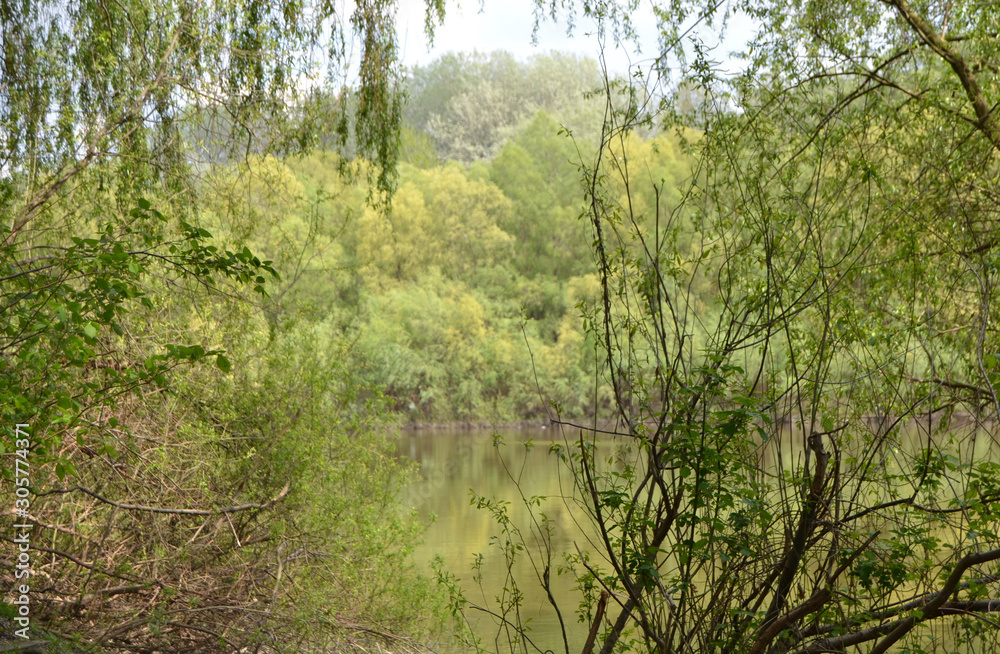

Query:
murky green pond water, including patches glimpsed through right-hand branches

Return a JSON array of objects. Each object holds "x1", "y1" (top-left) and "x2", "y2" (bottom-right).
[{"x1": 397, "y1": 425, "x2": 1000, "y2": 653}]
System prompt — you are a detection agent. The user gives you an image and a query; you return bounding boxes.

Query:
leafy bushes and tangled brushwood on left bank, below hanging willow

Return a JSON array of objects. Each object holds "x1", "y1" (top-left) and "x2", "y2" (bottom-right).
[{"x1": 0, "y1": 188, "x2": 448, "y2": 652}]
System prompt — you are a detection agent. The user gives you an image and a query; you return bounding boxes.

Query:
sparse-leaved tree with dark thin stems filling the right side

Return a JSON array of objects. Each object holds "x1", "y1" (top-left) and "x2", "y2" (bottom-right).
[{"x1": 452, "y1": 0, "x2": 1000, "y2": 654}]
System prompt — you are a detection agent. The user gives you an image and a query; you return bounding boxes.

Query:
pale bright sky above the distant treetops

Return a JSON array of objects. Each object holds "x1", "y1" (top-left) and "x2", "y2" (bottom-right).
[{"x1": 397, "y1": 0, "x2": 752, "y2": 75}]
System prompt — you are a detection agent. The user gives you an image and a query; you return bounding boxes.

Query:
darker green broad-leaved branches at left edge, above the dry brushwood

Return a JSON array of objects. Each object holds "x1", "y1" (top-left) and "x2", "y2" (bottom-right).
[{"x1": 0, "y1": 199, "x2": 277, "y2": 476}]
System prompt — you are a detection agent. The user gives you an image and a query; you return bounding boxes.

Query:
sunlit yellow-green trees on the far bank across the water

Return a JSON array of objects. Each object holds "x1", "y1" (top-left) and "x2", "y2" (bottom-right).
[{"x1": 203, "y1": 53, "x2": 668, "y2": 423}]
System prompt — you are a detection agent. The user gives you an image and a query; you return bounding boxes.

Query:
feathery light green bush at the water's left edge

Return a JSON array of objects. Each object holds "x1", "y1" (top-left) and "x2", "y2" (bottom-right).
[{"x1": 204, "y1": 323, "x2": 448, "y2": 651}]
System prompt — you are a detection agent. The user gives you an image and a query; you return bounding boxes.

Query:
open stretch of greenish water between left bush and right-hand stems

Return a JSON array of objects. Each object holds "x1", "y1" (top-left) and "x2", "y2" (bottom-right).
[{"x1": 397, "y1": 429, "x2": 594, "y2": 651}]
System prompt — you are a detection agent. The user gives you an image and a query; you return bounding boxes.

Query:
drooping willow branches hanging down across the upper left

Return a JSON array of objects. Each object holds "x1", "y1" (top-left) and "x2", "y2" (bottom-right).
[{"x1": 0, "y1": 0, "x2": 441, "y2": 205}]
